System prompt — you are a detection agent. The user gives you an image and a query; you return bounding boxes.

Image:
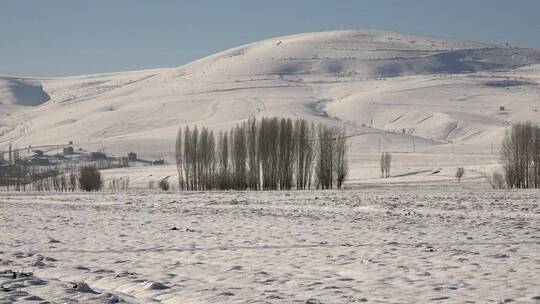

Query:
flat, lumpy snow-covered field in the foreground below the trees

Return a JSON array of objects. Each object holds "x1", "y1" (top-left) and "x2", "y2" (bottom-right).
[{"x1": 0, "y1": 189, "x2": 540, "y2": 303}]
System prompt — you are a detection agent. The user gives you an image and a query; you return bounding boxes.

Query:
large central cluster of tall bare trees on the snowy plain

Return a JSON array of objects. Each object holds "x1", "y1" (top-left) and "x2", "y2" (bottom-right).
[{"x1": 176, "y1": 117, "x2": 348, "y2": 191}]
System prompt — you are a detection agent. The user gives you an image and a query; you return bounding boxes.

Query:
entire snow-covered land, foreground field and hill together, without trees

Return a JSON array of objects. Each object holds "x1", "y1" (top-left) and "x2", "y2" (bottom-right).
[{"x1": 0, "y1": 27, "x2": 540, "y2": 304}]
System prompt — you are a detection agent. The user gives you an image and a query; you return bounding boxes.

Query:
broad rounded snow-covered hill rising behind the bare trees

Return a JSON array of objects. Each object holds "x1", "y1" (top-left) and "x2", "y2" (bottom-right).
[{"x1": 0, "y1": 31, "x2": 540, "y2": 156}]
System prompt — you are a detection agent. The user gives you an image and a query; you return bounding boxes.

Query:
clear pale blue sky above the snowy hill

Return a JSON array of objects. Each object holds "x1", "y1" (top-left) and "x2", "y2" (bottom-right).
[{"x1": 0, "y1": 0, "x2": 540, "y2": 76}]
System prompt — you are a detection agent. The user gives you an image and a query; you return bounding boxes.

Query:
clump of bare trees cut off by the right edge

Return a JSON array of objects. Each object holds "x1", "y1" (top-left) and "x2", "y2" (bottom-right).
[{"x1": 502, "y1": 122, "x2": 540, "y2": 188}]
